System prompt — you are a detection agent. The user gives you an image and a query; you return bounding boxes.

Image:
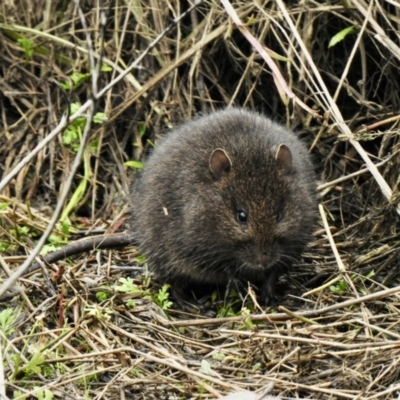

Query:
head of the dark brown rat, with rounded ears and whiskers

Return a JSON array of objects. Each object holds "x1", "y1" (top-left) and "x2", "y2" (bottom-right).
[{"x1": 182, "y1": 143, "x2": 313, "y2": 280}]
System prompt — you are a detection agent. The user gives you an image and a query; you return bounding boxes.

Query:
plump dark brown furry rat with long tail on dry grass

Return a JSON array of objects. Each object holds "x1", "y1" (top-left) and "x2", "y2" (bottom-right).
[{"x1": 26, "y1": 108, "x2": 317, "y2": 303}]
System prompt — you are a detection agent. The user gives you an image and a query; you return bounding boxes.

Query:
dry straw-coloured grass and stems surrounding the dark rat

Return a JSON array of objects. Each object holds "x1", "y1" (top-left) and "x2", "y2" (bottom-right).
[{"x1": 0, "y1": 0, "x2": 400, "y2": 400}]
